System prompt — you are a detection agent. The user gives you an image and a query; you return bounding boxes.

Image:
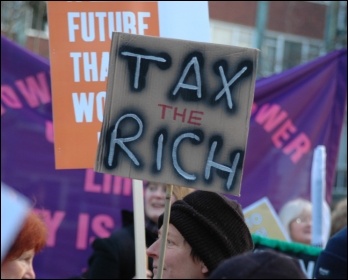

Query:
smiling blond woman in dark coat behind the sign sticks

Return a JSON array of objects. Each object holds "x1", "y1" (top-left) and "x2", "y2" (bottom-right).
[{"x1": 83, "y1": 182, "x2": 193, "y2": 279}]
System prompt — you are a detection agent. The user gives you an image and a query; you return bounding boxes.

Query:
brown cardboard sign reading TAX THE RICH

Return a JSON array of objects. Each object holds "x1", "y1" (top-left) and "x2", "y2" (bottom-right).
[{"x1": 95, "y1": 32, "x2": 258, "y2": 195}]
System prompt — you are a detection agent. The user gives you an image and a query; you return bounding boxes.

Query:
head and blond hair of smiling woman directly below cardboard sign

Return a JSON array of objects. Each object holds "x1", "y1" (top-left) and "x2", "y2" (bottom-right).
[{"x1": 144, "y1": 182, "x2": 192, "y2": 223}]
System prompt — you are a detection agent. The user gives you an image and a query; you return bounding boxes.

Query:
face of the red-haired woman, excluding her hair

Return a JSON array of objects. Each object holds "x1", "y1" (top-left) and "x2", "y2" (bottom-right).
[{"x1": 1, "y1": 250, "x2": 35, "y2": 279}]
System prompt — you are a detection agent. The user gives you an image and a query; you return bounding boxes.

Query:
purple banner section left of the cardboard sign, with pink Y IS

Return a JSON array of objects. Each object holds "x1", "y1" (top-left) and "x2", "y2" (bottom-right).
[{"x1": 1, "y1": 36, "x2": 132, "y2": 279}]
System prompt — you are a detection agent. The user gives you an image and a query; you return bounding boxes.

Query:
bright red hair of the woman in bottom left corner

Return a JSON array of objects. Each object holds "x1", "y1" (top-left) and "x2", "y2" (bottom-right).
[{"x1": 5, "y1": 211, "x2": 48, "y2": 261}]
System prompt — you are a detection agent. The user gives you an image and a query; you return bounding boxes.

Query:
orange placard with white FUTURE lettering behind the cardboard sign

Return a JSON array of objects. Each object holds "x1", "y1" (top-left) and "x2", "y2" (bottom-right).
[{"x1": 47, "y1": 1, "x2": 159, "y2": 169}]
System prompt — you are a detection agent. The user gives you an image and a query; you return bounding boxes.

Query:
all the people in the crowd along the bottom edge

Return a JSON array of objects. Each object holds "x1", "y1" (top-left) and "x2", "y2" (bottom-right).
[{"x1": 1, "y1": 182, "x2": 347, "y2": 279}]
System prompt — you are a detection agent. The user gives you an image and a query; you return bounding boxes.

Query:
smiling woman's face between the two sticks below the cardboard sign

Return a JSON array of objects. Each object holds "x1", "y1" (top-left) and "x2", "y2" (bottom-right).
[{"x1": 144, "y1": 182, "x2": 176, "y2": 223}]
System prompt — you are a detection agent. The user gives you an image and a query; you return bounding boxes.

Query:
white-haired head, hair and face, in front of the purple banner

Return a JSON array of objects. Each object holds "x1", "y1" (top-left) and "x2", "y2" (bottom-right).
[{"x1": 279, "y1": 198, "x2": 312, "y2": 245}]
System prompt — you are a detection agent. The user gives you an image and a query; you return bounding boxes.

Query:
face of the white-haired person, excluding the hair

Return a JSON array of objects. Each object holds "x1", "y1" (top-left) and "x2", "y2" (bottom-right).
[{"x1": 289, "y1": 210, "x2": 312, "y2": 245}]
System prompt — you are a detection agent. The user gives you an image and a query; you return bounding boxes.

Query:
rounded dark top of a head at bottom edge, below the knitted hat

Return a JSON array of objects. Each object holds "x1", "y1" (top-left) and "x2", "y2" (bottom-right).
[{"x1": 209, "y1": 250, "x2": 307, "y2": 279}]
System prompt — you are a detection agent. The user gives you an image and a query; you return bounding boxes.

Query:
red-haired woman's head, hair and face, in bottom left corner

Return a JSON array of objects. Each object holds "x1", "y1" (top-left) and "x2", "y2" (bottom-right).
[{"x1": 1, "y1": 211, "x2": 47, "y2": 279}]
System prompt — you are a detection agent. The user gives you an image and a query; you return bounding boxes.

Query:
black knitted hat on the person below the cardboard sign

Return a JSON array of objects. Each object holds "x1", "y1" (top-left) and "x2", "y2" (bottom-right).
[{"x1": 158, "y1": 190, "x2": 254, "y2": 271}]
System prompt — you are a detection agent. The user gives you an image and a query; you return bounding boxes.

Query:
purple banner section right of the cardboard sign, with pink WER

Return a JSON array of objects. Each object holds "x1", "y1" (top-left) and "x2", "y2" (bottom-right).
[{"x1": 238, "y1": 49, "x2": 347, "y2": 211}]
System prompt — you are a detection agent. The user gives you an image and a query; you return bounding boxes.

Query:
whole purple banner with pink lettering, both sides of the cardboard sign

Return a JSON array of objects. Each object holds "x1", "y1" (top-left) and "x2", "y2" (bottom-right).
[{"x1": 1, "y1": 36, "x2": 347, "y2": 279}]
